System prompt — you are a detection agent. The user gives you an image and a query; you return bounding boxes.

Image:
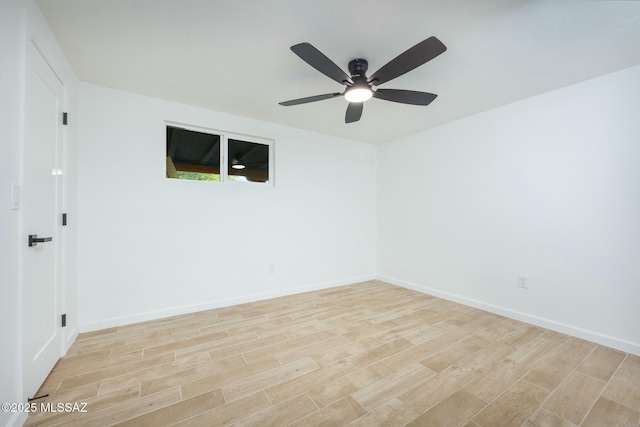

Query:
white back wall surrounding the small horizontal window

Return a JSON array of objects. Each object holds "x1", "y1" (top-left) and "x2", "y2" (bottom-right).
[{"x1": 78, "y1": 84, "x2": 376, "y2": 330}]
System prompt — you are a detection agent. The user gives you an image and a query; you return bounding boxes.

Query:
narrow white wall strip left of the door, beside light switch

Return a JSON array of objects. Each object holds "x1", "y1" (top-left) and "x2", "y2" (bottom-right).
[{"x1": 0, "y1": 0, "x2": 26, "y2": 426}]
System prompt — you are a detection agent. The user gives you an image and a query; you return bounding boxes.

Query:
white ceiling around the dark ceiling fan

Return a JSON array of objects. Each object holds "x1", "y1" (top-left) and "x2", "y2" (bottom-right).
[{"x1": 37, "y1": 0, "x2": 640, "y2": 143}]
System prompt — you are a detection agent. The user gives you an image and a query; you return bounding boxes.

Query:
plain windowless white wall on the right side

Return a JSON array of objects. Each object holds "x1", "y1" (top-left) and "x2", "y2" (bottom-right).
[{"x1": 378, "y1": 67, "x2": 640, "y2": 354}]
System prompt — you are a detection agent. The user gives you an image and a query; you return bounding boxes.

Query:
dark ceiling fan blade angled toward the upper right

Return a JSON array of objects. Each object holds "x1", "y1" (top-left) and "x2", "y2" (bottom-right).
[{"x1": 369, "y1": 36, "x2": 447, "y2": 86}]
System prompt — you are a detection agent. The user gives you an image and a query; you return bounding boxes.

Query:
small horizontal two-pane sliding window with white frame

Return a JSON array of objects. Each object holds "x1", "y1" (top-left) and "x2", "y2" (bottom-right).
[{"x1": 166, "y1": 124, "x2": 273, "y2": 184}]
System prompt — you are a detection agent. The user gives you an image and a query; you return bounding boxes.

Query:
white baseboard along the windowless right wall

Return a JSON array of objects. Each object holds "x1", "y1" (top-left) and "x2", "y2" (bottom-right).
[{"x1": 378, "y1": 275, "x2": 640, "y2": 356}]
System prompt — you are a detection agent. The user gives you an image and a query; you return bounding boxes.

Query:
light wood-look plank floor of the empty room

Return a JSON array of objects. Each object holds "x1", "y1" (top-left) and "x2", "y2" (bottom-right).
[{"x1": 26, "y1": 281, "x2": 640, "y2": 427}]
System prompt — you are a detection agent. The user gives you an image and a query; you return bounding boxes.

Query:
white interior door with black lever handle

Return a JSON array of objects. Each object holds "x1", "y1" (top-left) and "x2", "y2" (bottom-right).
[{"x1": 22, "y1": 43, "x2": 64, "y2": 397}]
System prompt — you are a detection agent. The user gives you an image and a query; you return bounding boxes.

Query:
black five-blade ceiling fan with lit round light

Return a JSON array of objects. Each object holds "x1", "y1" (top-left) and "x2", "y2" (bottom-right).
[{"x1": 279, "y1": 36, "x2": 447, "y2": 123}]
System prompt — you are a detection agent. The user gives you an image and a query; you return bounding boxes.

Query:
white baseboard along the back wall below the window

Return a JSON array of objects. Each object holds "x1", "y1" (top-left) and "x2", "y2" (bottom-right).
[{"x1": 81, "y1": 276, "x2": 376, "y2": 339}]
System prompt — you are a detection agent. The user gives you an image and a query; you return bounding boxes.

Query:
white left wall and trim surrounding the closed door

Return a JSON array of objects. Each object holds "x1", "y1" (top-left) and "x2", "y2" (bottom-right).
[{"x1": 0, "y1": 0, "x2": 77, "y2": 426}]
